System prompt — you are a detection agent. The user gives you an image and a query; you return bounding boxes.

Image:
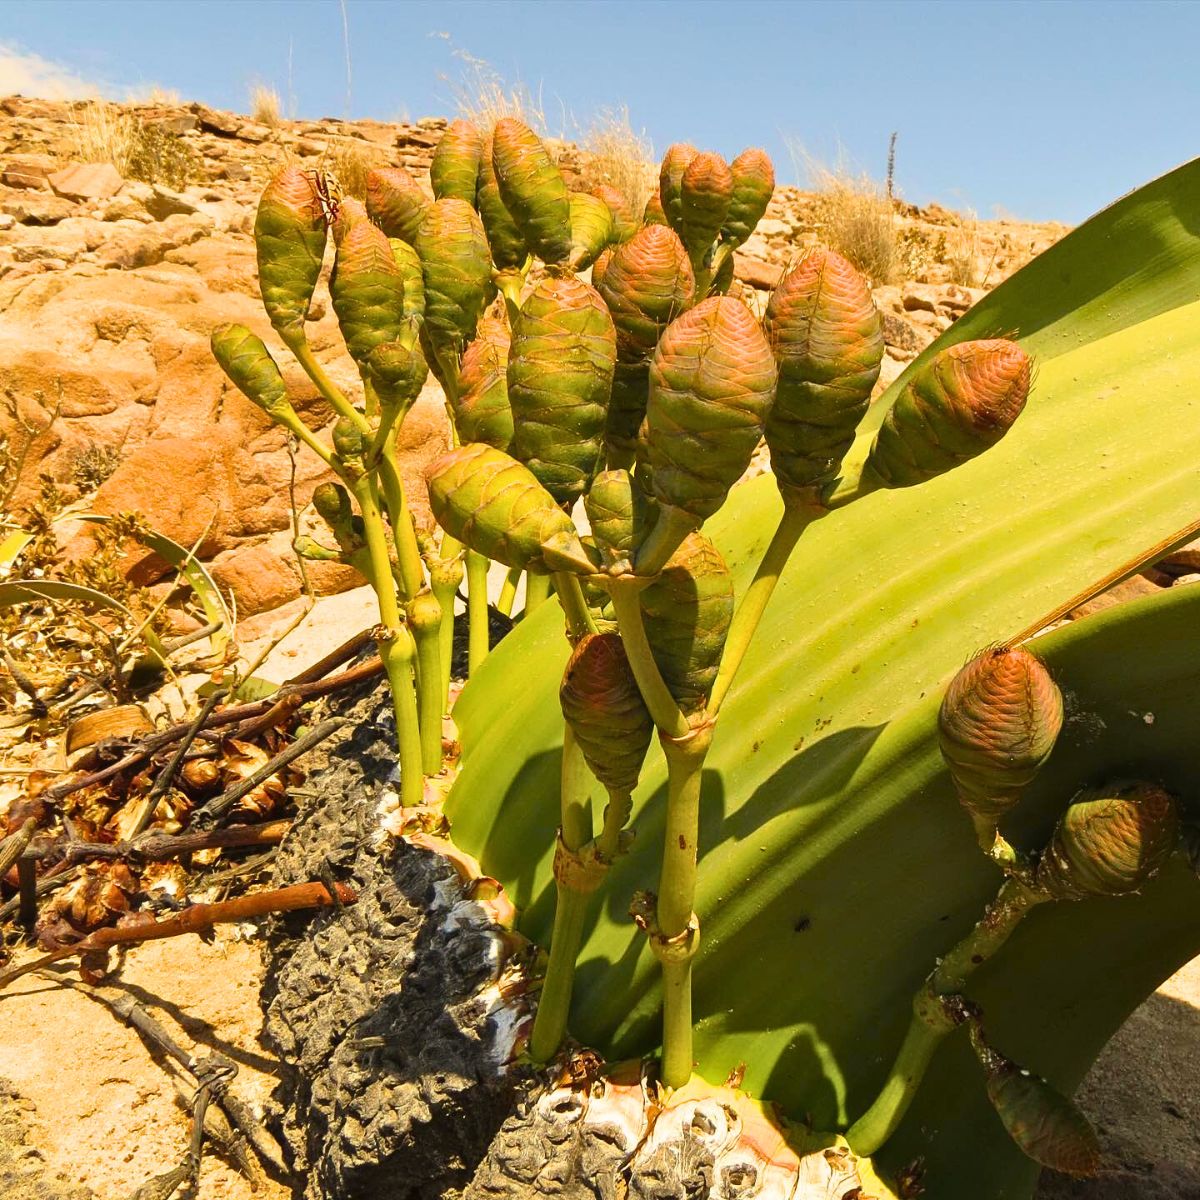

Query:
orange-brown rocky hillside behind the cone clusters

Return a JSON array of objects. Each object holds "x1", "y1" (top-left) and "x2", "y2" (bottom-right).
[{"x1": 0, "y1": 97, "x2": 1064, "y2": 618}]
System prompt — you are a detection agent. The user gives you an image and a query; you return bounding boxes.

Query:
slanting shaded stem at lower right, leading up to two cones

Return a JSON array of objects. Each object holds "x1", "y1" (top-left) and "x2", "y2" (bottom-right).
[{"x1": 846, "y1": 878, "x2": 1050, "y2": 1154}]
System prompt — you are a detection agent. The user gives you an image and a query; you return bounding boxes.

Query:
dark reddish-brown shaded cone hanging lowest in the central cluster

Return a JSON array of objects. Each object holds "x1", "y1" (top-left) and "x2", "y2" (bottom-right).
[{"x1": 558, "y1": 634, "x2": 654, "y2": 794}]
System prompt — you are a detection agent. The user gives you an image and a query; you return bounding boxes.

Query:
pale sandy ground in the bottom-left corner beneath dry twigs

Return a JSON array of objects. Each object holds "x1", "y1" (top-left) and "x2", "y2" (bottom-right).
[{"x1": 0, "y1": 929, "x2": 288, "y2": 1200}]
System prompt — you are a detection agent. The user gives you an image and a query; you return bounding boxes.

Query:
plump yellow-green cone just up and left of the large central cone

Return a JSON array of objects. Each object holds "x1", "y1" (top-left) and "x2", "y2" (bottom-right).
[{"x1": 416, "y1": 199, "x2": 496, "y2": 354}]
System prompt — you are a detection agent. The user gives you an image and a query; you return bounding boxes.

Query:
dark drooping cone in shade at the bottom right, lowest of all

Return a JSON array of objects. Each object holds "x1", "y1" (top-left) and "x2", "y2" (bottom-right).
[{"x1": 976, "y1": 1045, "x2": 1103, "y2": 1176}]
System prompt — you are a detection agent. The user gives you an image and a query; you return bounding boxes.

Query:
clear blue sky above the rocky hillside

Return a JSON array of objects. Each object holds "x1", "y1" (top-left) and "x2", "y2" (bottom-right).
[{"x1": 0, "y1": 0, "x2": 1200, "y2": 222}]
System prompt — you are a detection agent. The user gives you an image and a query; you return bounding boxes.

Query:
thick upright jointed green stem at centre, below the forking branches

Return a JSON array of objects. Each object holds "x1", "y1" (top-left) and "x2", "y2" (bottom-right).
[{"x1": 652, "y1": 728, "x2": 712, "y2": 1087}]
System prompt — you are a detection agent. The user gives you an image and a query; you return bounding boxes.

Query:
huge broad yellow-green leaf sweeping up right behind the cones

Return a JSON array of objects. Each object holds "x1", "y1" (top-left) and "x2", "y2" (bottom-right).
[{"x1": 449, "y1": 162, "x2": 1200, "y2": 1200}]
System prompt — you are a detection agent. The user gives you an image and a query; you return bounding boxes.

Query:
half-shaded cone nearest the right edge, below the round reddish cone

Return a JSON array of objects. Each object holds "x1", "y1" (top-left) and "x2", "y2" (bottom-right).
[{"x1": 1036, "y1": 782, "x2": 1180, "y2": 900}]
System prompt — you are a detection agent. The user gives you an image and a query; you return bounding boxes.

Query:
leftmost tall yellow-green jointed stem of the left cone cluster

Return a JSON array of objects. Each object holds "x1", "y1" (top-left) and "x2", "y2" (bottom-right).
[{"x1": 354, "y1": 475, "x2": 425, "y2": 808}]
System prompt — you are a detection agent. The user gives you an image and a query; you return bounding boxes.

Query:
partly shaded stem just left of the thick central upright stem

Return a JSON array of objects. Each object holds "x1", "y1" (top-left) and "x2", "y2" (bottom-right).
[{"x1": 529, "y1": 726, "x2": 592, "y2": 1062}]
